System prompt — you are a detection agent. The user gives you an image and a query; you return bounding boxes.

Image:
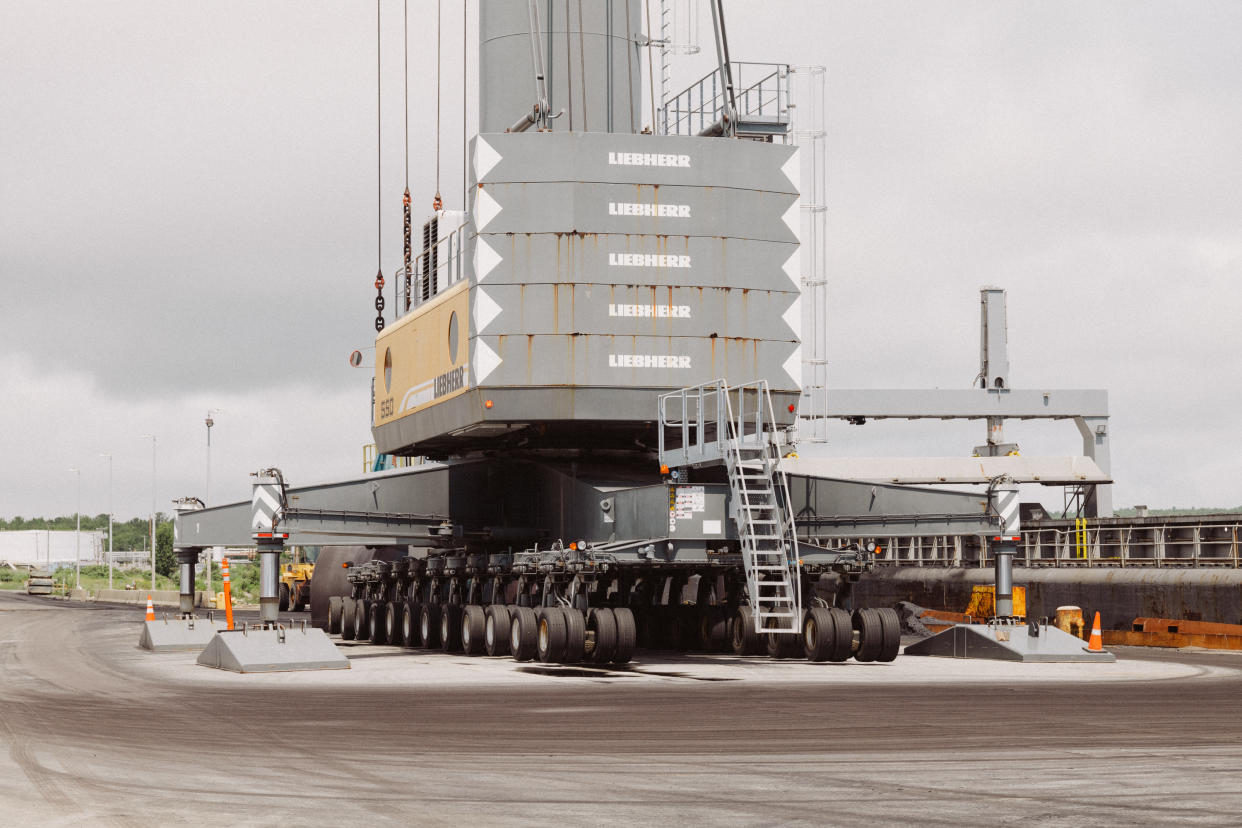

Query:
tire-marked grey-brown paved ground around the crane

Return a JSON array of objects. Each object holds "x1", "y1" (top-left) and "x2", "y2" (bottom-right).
[{"x1": 0, "y1": 595, "x2": 1242, "y2": 828}]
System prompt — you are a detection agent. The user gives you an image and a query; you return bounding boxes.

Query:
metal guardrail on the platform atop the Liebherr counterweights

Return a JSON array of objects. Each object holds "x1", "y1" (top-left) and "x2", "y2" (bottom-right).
[{"x1": 660, "y1": 62, "x2": 789, "y2": 135}]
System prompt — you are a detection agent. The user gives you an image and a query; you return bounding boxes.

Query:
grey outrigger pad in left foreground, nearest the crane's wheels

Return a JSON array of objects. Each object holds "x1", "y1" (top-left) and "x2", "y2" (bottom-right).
[{"x1": 199, "y1": 627, "x2": 349, "y2": 673}]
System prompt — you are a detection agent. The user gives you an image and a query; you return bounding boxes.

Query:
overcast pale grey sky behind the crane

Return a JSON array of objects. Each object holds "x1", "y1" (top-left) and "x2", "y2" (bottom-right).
[{"x1": 0, "y1": 0, "x2": 1242, "y2": 516}]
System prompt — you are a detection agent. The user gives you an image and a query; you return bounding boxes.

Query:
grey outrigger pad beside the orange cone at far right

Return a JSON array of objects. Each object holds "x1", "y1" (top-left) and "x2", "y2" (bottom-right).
[{"x1": 905, "y1": 624, "x2": 1117, "y2": 663}]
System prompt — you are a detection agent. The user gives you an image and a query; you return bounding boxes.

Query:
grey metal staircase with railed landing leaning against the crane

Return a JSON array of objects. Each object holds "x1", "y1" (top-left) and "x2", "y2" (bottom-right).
[{"x1": 660, "y1": 380, "x2": 802, "y2": 633}]
